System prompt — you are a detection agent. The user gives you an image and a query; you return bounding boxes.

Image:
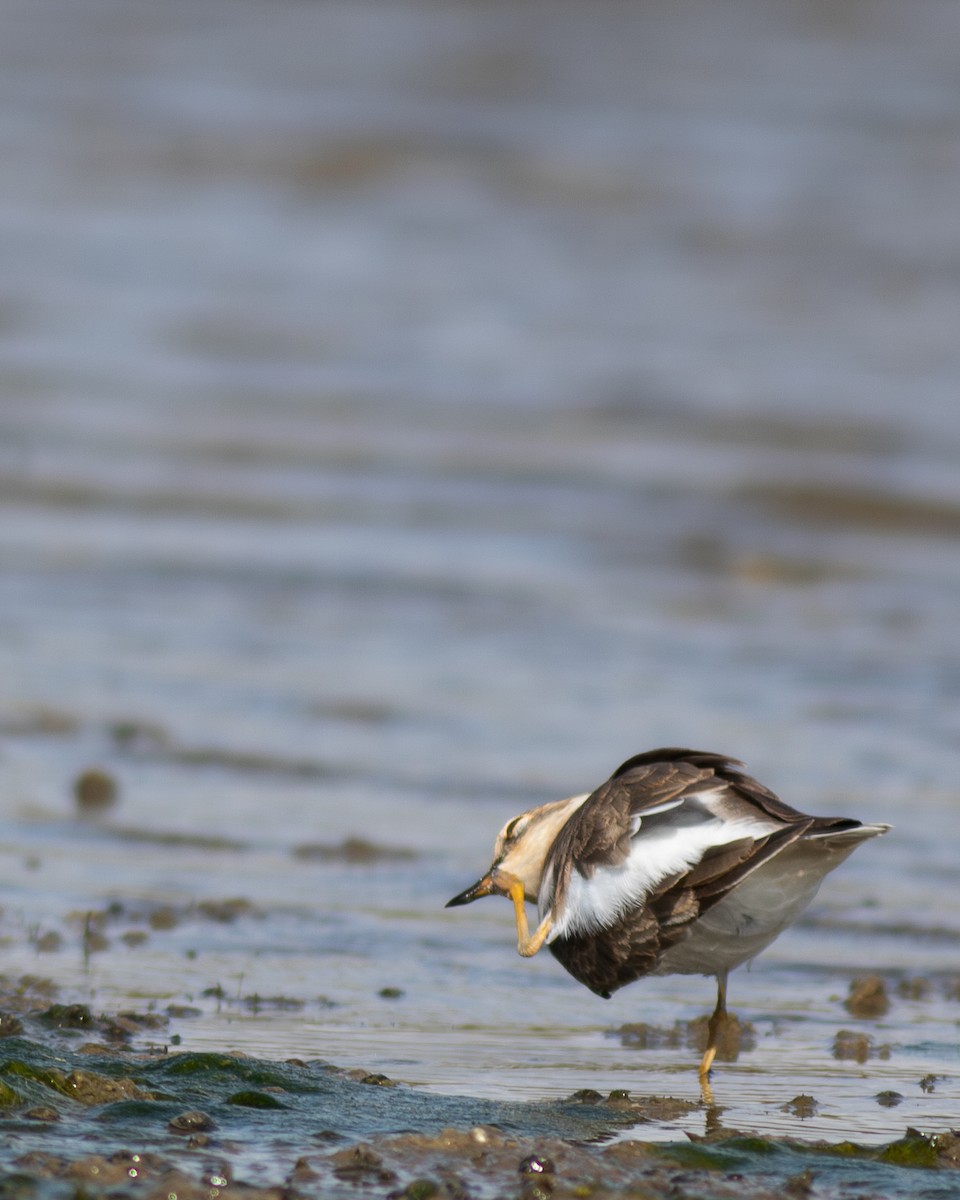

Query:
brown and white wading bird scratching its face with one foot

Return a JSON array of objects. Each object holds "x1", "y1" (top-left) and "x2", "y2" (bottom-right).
[{"x1": 446, "y1": 749, "x2": 889, "y2": 1092}]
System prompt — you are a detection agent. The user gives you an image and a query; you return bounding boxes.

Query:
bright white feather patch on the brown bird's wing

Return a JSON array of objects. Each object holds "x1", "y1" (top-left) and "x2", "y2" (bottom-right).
[{"x1": 547, "y1": 788, "x2": 781, "y2": 942}]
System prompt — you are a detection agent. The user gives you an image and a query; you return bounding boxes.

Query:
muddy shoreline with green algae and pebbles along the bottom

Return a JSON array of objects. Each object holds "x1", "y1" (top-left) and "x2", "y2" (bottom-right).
[{"x1": 0, "y1": 977, "x2": 960, "y2": 1200}]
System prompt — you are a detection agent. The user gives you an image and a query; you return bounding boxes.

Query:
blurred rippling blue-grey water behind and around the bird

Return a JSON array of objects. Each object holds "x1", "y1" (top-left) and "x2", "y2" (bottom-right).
[{"x1": 0, "y1": 0, "x2": 960, "y2": 1140}]
